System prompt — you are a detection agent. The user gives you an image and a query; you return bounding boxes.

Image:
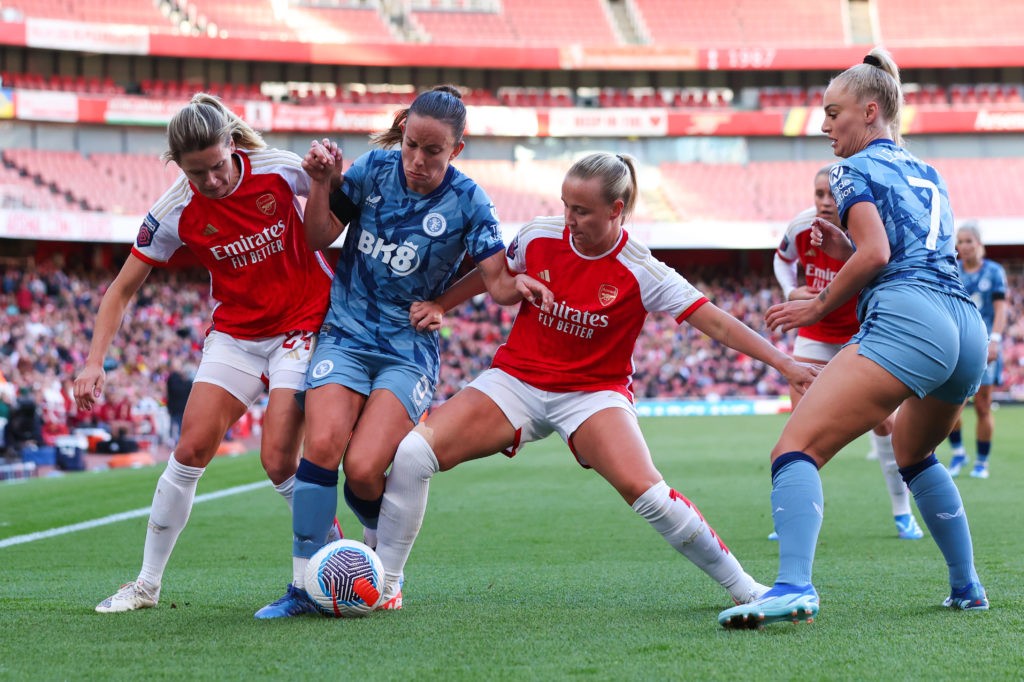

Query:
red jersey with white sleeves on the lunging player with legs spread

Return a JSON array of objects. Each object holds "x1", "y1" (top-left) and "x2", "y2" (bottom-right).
[{"x1": 493, "y1": 216, "x2": 708, "y2": 399}]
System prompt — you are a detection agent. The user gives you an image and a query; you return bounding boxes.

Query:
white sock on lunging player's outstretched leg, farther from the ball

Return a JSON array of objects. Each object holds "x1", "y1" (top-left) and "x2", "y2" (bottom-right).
[{"x1": 633, "y1": 480, "x2": 756, "y2": 601}]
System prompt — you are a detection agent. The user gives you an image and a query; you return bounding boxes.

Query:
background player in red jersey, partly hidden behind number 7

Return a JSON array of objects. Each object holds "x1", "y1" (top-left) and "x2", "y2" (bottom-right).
[{"x1": 769, "y1": 166, "x2": 925, "y2": 540}]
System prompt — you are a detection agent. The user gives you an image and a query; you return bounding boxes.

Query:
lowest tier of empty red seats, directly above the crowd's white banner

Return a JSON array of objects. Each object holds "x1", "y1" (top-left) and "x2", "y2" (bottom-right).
[{"x1": 0, "y1": 148, "x2": 1024, "y2": 223}]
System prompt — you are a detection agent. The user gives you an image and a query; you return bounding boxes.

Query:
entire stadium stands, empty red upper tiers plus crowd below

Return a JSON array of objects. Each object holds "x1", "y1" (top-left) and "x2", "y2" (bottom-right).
[{"x1": 0, "y1": 0, "x2": 1024, "y2": 477}]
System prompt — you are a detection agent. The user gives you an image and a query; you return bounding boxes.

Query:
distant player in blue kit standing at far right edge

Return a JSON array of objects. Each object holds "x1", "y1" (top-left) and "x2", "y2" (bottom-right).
[{"x1": 949, "y1": 223, "x2": 1007, "y2": 478}]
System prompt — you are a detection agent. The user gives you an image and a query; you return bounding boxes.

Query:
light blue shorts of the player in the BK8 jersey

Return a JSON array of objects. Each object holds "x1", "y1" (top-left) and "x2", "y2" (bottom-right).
[{"x1": 306, "y1": 334, "x2": 437, "y2": 424}]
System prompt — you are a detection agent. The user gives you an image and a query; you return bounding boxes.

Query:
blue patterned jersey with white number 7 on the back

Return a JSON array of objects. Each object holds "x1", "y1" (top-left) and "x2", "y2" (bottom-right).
[{"x1": 828, "y1": 139, "x2": 968, "y2": 319}]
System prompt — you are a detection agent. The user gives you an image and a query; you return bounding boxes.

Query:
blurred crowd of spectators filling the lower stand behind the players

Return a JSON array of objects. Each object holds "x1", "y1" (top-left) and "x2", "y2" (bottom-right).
[{"x1": 0, "y1": 257, "x2": 1024, "y2": 462}]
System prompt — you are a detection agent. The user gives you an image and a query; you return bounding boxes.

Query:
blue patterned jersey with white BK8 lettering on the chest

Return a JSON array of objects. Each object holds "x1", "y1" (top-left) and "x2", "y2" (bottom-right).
[{"x1": 323, "y1": 150, "x2": 504, "y2": 377}]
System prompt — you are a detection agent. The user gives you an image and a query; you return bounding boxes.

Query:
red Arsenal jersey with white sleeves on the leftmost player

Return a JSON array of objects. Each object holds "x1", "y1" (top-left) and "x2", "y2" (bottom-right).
[{"x1": 132, "y1": 150, "x2": 331, "y2": 339}]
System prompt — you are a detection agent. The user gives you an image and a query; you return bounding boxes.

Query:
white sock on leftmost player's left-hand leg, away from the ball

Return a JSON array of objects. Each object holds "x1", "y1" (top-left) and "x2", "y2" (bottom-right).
[{"x1": 138, "y1": 453, "x2": 206, "y2": 589}]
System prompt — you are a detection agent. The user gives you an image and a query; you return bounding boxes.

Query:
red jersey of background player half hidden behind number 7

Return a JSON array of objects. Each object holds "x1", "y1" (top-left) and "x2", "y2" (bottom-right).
[{"x1": 778, "y1": 208, "x2": 860, "y2": 343}]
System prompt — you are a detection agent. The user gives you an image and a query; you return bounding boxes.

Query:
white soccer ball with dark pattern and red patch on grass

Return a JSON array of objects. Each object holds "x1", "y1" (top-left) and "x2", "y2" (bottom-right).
[{"x1": 306, "y1": 540, "x2": 384, "y2": 619}]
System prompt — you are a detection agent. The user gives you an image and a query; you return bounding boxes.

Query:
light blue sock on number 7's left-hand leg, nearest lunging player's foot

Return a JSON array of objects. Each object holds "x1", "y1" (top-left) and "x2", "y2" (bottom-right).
[{"x1": 771, "y1": 453, "x2": 824, "y2": 587}]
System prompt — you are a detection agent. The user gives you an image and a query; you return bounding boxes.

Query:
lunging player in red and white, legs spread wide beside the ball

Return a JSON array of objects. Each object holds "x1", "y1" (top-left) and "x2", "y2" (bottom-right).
[{"x1": 377, "y1": 153, "x2": 817, "y2": 608}]
